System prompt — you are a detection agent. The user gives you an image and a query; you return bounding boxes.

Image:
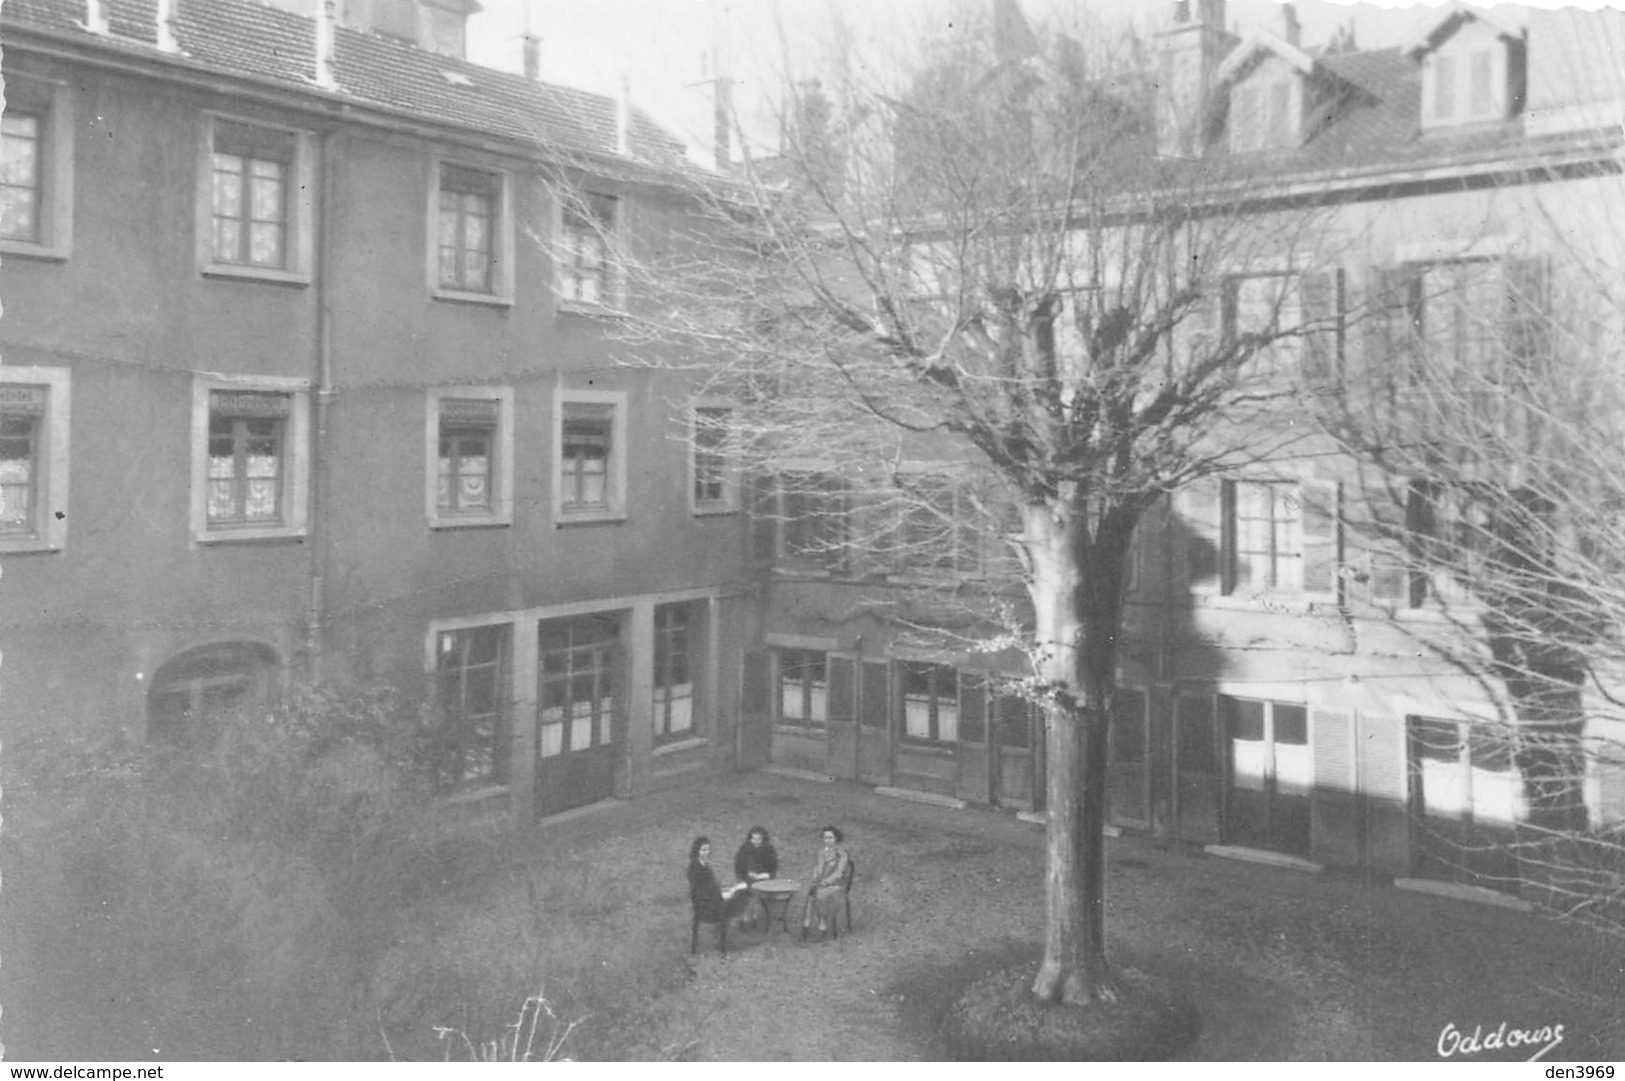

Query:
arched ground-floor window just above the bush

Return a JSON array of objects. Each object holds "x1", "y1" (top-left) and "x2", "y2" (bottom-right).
[{"x1": 146, "y1": 642, "x2": 278, "y2": 746}]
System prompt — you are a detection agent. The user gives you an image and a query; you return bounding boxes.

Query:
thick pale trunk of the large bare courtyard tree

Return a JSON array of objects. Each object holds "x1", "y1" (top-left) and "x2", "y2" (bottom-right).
[{"x1": 1027, "y1": 507, "x2": 1116, "y2": 1005}]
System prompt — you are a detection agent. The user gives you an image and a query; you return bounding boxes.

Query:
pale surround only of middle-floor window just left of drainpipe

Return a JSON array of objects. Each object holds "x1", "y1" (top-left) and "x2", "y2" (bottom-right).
[{"x1": 190, "y1": 372, "x2": 310, "y2": 545}]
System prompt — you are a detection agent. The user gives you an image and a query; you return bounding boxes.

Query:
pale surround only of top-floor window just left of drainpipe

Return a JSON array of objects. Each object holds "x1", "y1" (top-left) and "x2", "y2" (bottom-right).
[{"x1": 197, "y1": 111, "x2": 317, "y2": 286}]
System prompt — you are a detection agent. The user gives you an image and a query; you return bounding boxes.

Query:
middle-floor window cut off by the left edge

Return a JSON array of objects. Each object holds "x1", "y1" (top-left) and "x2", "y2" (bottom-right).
[{"x1": 0, "y1": 367, "x2": 68, "y2": 553}]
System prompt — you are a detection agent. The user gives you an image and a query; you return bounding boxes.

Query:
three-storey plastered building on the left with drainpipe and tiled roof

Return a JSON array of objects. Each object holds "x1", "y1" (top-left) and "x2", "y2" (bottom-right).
[{"x1": 0, "y1": 0, "x2": 752, "y2": 819}]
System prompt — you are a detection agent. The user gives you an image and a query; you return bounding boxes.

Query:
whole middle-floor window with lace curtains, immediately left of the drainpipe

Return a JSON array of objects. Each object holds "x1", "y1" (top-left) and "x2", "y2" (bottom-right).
[{"x1": 192, "y1": 376, "x2": 310, "y2": 541}]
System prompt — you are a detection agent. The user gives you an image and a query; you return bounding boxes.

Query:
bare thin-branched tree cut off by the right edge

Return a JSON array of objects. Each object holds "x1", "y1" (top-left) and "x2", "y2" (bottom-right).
[{"x1": 1318, "y1": 195, "x2": 1625, "y2": 931}]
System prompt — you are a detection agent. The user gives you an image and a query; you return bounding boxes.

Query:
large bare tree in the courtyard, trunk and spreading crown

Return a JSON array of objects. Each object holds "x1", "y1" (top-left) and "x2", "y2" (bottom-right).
[{"x1": 552, "y1": 10, "x2": 1321, "y2": 1003}]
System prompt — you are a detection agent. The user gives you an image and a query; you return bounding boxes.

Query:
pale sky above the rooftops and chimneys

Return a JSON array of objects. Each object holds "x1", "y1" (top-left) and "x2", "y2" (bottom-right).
[{"x1": 468, "y1": 0, "x2": 1625, "y2": 165}]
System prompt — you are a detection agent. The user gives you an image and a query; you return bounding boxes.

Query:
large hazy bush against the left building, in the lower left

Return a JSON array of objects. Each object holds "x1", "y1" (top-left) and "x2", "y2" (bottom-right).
[{"x1": 7, "y1": 686, "x2": 432, "y2": 1058}]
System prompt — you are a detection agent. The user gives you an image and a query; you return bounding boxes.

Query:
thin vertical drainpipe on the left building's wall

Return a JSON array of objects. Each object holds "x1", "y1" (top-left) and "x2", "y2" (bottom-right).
[{"x1": 304, "y1": 130, "x2": 336, "y2": 683}]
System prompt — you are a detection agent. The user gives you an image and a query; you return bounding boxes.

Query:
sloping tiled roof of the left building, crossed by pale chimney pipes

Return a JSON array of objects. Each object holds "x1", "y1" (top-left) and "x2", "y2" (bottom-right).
[{"x1": 0, "y1": 0, "x2": 684, "y2": 167}]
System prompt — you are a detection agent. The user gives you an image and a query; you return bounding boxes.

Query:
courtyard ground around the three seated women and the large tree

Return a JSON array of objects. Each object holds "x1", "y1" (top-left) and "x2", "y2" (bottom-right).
[{"x1": 409, "y1": 774, "x2": 1625, "y2": 1061}]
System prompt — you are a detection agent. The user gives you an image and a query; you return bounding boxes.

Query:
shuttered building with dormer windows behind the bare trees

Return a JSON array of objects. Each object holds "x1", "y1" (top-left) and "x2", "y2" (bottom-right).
[{"x1": 741, "y1": 0, "x2": 1625, "y2": 881}]
